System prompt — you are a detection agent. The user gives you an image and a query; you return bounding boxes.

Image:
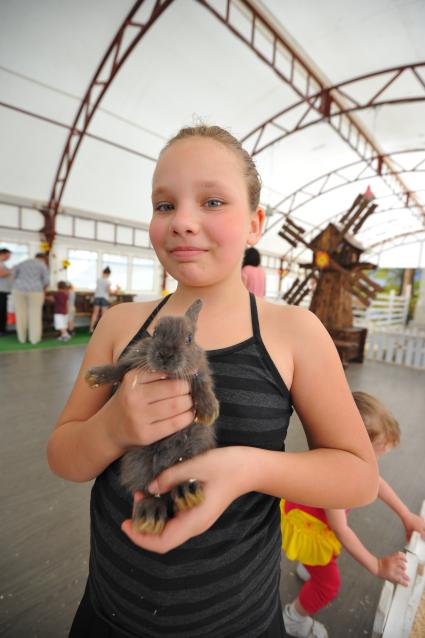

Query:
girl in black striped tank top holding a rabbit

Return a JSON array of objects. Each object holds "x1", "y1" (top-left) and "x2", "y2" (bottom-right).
[{"x1": 48, "y1": 126, "x2": 378, "y2": 638}]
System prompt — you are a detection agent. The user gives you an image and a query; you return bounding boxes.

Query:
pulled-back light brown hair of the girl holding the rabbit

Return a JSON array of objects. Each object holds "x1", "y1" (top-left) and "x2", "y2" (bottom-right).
[{"x1": 161, "y1": 124, "x2": 261, "y2": 211}]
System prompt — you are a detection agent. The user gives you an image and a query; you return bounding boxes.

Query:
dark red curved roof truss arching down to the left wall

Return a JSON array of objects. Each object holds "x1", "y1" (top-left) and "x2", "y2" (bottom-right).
[{"x1": 42, "y1": 0, "x2": 174, "y2": 218}]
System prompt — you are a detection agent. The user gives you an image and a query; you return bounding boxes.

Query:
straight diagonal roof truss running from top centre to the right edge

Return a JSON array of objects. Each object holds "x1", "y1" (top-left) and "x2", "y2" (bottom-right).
[{"x1": 198, "y1": 0, "x2": 425, "y2": 217}]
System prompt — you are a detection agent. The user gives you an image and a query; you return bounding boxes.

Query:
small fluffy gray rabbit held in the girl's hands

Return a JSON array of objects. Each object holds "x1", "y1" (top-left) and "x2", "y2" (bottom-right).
[{"x1": 86, "y1": 299, "x2": 219, "y2": 534}]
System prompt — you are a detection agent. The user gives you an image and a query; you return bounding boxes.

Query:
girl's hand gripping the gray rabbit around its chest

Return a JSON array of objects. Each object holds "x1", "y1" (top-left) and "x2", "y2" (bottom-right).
[{"x1": 110, "y1": 370, "x2": 194, "y2": 448}]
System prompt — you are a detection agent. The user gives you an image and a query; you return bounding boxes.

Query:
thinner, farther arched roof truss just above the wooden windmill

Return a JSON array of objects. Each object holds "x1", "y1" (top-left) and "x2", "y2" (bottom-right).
[{"x1": 264, "y1": 148, "x2": 425, "y2": 234}]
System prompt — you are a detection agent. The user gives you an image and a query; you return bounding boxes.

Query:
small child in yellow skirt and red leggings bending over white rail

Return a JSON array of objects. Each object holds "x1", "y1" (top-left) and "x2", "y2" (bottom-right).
[{"x1": 281, "y1": 392, "x2": 425, "y2": 638}]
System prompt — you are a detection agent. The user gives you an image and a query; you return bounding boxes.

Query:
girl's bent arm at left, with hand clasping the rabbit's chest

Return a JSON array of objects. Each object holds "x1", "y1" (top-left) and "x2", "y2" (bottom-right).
[{"x1": 47, "y1": 304, "x2": 193, "y2": 481}]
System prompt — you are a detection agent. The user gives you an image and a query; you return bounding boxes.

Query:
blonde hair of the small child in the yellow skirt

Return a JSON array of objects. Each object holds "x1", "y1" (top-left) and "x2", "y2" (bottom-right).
[{"x1": 353, "y1": 392, "x2": 400, "y2": 447}]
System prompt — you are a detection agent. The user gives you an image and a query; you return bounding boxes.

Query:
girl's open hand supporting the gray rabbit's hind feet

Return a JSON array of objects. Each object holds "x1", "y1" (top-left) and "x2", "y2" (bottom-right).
[{"x1": 121, "y1": 447, "x2": 253, "y2": 554}]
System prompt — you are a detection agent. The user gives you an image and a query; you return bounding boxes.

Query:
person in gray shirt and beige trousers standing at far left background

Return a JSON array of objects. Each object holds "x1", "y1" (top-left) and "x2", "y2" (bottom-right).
[{"x1": 12, "y1": 253, "x2": 49, "y2": 344}]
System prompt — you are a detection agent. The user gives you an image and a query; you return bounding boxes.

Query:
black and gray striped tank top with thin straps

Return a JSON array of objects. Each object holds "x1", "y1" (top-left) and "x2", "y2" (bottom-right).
[{"x1": 88, "y1": 295, "x2": 292, "y2": 638}]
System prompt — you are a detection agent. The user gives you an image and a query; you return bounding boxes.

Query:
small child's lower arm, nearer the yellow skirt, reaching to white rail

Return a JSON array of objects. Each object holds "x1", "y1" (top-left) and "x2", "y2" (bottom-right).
[{"x1": 325, "y1": 509, "x2": 409, "y2": 585}]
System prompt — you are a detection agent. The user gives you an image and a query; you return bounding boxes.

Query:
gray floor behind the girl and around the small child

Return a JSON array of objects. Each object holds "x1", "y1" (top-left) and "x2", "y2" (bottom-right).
[{"x1": 0, "y1": 347, "x2": 425, "y2": 638}]
